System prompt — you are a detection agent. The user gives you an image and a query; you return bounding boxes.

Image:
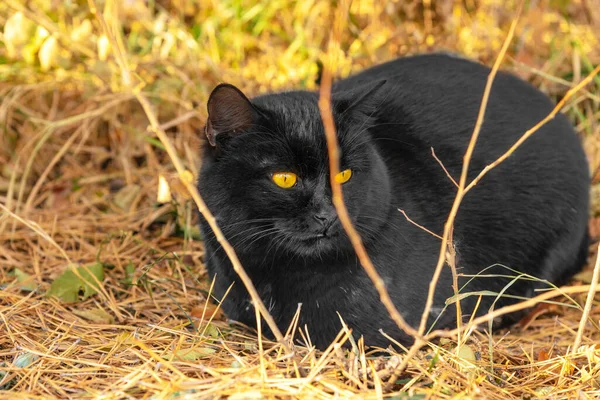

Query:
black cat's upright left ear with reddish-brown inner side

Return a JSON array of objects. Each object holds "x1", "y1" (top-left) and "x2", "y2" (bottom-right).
[{"x1": 205, "y1": 83, "x2": 257, "y2": 147}]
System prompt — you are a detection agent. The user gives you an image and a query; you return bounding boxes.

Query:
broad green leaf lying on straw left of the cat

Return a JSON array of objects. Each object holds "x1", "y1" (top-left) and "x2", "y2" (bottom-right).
[{"x1": 46, "y1": 263, "x2": 104, "y2": 303}]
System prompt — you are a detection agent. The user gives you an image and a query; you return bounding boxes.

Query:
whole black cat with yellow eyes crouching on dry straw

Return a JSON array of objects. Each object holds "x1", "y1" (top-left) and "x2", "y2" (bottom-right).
[{"x1": 198, "y1": 54, "x2": 590, "y2": 348}]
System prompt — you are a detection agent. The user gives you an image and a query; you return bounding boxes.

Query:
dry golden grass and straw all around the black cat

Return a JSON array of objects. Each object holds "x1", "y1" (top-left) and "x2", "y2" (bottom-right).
[{"x1": 0, "y1": 0, "x2": 600, "y2": 399}]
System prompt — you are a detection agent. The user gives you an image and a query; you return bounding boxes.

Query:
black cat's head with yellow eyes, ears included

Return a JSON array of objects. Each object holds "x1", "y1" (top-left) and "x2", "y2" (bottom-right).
[{"x1": 198, "y1": 82, "x2": 390, "y2": 258}]
